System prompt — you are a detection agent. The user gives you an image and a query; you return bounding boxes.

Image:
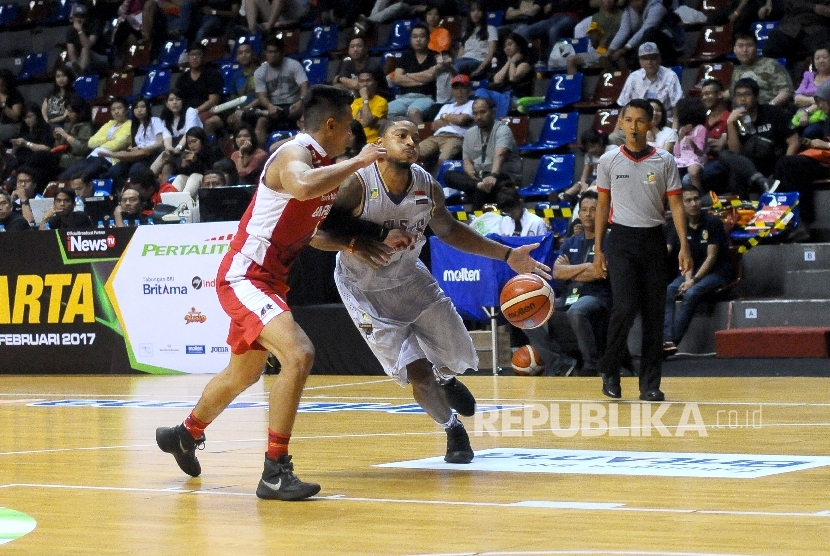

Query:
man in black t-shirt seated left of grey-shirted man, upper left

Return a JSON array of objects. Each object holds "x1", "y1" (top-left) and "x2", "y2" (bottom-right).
[{"x1": 175, "y1": 42, "x2": 224, "y2": 135}]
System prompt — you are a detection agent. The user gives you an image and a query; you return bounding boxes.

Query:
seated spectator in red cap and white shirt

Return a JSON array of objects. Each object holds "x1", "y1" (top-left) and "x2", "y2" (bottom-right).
[{"x1": 420, "y1": 73, "x2": 473, "y2": 173}]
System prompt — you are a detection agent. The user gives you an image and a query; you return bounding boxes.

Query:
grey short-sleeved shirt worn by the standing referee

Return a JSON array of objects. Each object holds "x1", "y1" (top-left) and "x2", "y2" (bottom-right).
[{"x1": 597, "y1": 147, "x2": 681, "y2": 228}]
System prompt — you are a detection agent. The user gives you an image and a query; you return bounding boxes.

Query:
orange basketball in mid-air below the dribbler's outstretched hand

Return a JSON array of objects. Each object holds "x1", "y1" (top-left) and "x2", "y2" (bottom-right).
[{"x1": 499, "y1": 274, "x2": 555, "y2": 329}]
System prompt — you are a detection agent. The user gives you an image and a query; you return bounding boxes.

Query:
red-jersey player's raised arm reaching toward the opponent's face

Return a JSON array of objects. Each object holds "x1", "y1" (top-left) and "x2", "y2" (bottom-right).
[{"x1": 272, "y1": 143, "x2": 386, "y2": 201}]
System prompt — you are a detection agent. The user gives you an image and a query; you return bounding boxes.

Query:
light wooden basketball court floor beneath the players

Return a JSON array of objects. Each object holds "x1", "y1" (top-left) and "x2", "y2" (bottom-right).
[{"x1": 0, "y1": 375, "x2": 830, "y2": 556}]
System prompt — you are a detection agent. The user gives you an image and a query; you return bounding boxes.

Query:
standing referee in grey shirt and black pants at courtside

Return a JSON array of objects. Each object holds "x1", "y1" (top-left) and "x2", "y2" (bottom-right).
[{"x1": 594, "y1": 99, "x2": 692, "y2": 402}]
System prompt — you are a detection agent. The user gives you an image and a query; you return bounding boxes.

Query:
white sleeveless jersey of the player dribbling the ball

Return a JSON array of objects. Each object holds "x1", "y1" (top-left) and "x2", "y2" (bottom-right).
[{"x1": 336, "y1": 163, "x2": 435, "y2": 291}]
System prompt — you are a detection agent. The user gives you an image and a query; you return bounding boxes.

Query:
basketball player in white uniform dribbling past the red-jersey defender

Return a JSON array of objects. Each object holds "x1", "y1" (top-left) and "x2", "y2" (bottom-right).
[{"x1": 311, "y1": 120, "x2": 550, "y2": 463}]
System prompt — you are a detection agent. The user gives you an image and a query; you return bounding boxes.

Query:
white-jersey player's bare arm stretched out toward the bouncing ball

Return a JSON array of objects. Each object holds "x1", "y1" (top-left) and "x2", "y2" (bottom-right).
[{"x1": 429, "y1": 179, "x2": 551, "y2": 279}]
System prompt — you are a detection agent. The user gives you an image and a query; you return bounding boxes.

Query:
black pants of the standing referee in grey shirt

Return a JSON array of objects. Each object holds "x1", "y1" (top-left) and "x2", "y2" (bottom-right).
[{"x1": 597, "y1": 224, "x2": 668, "y2": 393}]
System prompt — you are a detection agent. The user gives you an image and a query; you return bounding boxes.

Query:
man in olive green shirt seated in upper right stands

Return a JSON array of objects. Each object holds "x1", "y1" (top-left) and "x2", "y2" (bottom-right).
[{"x1": 730, "y1": 33, "x2": 794, "y2": 107}]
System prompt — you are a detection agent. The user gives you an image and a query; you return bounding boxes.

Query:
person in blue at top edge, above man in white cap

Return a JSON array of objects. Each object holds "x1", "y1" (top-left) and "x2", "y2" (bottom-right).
[{"x1": 608, "y1": 0, "x2": 685, "y2": 69}]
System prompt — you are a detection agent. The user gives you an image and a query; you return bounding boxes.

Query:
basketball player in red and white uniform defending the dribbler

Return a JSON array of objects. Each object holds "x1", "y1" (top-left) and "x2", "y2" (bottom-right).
[{"x1": 156, "y1": 85, "x2": 411, "y2": 500}]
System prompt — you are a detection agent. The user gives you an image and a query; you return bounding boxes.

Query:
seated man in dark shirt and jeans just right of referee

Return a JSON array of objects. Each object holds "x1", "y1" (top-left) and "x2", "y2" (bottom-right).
[{"x1": 663, "y1": 185, "x2": 732, "y2": 355}]
